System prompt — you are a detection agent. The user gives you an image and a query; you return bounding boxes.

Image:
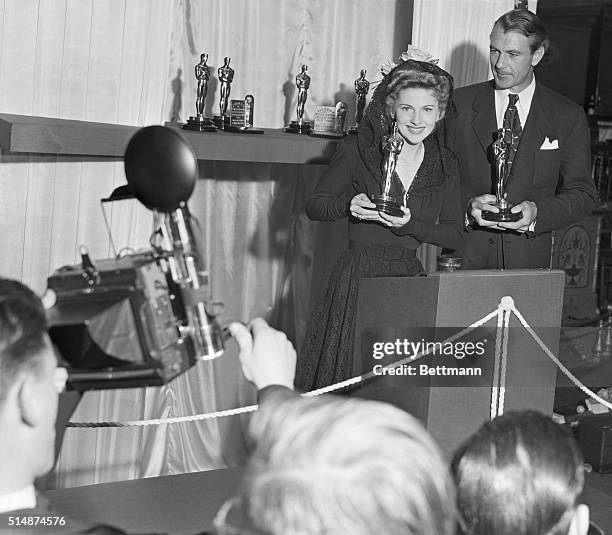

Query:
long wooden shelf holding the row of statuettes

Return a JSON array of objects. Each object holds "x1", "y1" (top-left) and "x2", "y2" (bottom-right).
[{"x1": 0, "y1": 114, "x2": 337, "y2": 164}]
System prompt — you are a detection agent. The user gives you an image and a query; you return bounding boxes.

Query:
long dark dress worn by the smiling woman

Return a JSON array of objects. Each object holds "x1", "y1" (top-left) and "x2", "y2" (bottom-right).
[{"x1": 295, "y1": 135, "x2": 463, "y2": 391}]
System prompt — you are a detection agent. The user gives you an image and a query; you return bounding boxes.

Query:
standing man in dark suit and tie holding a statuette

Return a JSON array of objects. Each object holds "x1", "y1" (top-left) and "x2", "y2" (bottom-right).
[{"x1": 455, "y1": 9, "x2": 595, "y2": 269}]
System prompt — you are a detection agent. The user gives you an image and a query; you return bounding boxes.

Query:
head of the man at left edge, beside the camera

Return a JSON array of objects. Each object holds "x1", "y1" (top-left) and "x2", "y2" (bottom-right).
[{"x1": 0, "y1": 279, "x2": 66, "y2": 492}]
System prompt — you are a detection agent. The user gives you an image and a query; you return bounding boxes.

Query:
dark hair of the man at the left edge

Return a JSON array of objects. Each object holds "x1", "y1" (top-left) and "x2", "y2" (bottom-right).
[{"x1": 0, "y1": 278, "x2": 47, "y2": 404}]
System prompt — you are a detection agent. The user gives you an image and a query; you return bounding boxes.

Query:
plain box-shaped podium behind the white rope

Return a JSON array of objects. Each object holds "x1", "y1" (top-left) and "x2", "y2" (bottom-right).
[{"x1": 351, "y1": 270, "x2": 565, "y2": 456}]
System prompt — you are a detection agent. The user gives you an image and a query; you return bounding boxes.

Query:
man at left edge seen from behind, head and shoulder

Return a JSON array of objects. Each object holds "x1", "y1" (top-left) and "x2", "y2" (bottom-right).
[{"x1": 0, "y1": 279, "x2": 122, "y2": 534}]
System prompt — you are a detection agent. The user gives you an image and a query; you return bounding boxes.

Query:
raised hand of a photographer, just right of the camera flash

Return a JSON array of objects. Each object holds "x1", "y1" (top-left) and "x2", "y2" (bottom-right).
[{"x1": 229, "y1": 318, "x2": 296, "y2": 390}]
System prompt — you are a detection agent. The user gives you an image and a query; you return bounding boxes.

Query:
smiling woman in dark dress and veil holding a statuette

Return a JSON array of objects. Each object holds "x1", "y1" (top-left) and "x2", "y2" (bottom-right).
[{"x1": 296, "y1": 60, "x2": 462, "y2": 390}]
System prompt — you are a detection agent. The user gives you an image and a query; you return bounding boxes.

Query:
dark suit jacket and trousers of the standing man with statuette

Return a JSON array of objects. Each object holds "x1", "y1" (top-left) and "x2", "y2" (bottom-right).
[{"x1": 455, "y1": 80, "x2": 595, "y2": 269}]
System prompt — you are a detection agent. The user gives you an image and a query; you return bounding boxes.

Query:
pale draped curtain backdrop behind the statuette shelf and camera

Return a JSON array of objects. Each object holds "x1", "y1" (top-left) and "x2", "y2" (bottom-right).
[{"x1": 0, "y1": 0, "x2": 403, "y2": 486}]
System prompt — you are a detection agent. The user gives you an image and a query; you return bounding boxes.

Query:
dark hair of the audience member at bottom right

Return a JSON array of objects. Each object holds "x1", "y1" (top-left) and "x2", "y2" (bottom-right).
[{"x1": 452, "y1": 411, "x2": 584, "y2": 535}]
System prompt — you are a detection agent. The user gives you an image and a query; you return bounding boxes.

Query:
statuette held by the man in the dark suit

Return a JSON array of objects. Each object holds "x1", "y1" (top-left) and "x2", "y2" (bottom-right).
[{"x1": 482, "y1": 128, "x2": 523, "y2": 222}]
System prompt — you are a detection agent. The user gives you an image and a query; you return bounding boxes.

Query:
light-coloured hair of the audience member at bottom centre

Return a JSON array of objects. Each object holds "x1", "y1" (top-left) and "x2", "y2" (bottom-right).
[{"x1": 242, "y1": 396, "x2": 456, "y2": 535}]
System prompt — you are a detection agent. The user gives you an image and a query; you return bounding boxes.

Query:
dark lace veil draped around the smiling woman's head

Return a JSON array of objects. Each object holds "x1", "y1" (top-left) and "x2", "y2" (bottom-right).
[{"x1": 357, "y1": 59, "x2": 457, "y2": 188}]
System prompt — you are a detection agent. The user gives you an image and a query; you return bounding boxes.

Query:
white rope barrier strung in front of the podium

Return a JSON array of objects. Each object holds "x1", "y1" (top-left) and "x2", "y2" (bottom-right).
[{"x1": 67, "y1": 296, "x2": 612, "y2": 428}]
